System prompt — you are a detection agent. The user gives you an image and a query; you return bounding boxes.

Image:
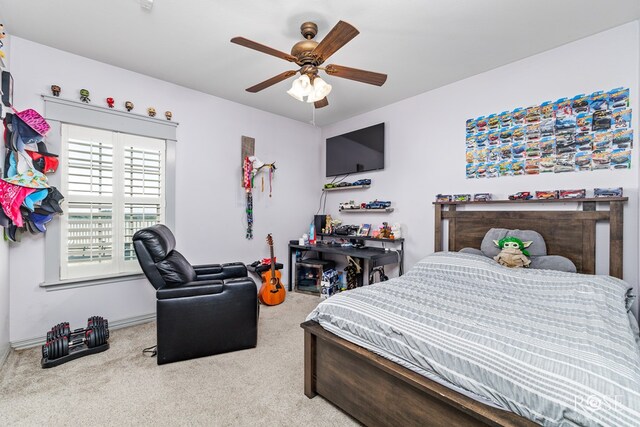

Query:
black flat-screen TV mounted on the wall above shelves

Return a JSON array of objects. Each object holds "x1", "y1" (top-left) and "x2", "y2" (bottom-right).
[{"x1": 326, "y1": 123, "x2": 384, "y2": 176}]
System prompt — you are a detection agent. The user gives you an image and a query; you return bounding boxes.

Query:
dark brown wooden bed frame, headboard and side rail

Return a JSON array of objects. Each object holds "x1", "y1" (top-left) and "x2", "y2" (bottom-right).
[{"x1": 301, "y1": 197, "x2": 627, "y2": 427}]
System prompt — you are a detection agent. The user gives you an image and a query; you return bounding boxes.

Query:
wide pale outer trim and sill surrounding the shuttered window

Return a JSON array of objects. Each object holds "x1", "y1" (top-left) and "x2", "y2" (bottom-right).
[{"x1": 40, "y1": 95, "x2": 178, "y2": 291}]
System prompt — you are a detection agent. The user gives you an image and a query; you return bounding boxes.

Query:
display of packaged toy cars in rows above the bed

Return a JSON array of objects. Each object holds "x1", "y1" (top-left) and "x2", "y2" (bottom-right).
[{"x1": 466, "y1": 88, "x2": 633, "y2": 178}]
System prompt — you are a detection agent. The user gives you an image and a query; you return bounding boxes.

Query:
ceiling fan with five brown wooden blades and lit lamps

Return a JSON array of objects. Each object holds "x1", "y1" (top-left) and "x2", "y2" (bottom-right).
[{"x1": 231, "y1": 21, "x2": 387, "y2": 108}]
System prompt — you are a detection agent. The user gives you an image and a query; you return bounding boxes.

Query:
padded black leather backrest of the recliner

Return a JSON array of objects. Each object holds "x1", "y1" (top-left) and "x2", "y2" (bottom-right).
[{"x1": 133, "y1": 224, "x2": 196, "y2": 289}]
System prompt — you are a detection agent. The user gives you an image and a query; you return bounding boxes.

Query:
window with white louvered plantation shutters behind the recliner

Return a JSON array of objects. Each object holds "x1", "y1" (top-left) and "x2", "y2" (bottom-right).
[{"x1": 60, "y1": 124, "x2": 166, "y2": 280}]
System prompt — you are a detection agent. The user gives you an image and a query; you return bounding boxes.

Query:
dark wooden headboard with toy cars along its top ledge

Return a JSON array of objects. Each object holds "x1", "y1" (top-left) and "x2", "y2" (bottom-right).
[{"x1": 434, "y1": 197, "x2": 628, "y2": 279}]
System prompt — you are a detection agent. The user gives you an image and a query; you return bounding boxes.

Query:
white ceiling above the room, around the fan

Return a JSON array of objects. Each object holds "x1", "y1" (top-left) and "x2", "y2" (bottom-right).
[{"x1": 0, "y1": 0, "x2": 640, "y2": 126}]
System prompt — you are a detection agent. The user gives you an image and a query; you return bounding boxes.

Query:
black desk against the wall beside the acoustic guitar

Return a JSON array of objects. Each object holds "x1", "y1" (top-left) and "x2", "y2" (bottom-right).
[{"x1": 288, "y1": 241, "x2": 404, "y2": 291}]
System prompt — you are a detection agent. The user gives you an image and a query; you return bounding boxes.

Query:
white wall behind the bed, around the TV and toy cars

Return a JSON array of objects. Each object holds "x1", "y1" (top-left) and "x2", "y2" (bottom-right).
[{"x1": 321, "y1": 22, "x2": 640, "y2": 318}]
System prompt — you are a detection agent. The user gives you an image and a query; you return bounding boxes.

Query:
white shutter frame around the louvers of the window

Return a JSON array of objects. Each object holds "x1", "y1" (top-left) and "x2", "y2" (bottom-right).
[{"x1": 59, "y1": 123, "x2": 166, "y2": 280}]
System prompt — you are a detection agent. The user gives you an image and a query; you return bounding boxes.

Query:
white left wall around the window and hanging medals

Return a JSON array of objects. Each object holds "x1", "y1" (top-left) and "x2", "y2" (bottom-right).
[{"x1": 9, "y1": 37, "x2": 321, "y2": 342}]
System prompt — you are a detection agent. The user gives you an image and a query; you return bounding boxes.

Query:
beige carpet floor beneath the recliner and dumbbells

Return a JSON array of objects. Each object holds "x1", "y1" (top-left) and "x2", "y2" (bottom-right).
[{"x1": 0, "y1": 293, "x2": 357, "y2": 426}]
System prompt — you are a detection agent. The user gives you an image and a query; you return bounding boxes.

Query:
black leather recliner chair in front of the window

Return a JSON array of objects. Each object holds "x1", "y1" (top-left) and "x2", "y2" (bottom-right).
[{"x1": 133, "y1": 224, "x2": 259, "y2": 365}]
